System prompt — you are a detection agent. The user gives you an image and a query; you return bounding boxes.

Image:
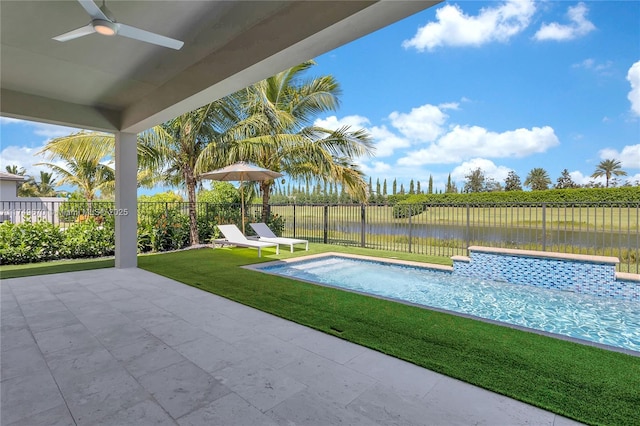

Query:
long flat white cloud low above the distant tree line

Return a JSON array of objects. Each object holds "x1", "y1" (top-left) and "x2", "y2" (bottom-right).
[{"x1": 398, "y1": 126, "x2": 560, "y2": 166}]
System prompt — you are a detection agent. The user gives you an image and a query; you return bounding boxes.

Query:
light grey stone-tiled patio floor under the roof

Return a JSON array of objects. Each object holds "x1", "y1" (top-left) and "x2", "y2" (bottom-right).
[{"x1": 0, "y1": 269, "x2": 578, "y2": 426}]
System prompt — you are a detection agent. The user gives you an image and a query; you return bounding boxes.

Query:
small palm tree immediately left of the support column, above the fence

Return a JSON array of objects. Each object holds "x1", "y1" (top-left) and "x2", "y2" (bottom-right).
[{"x1": 36, "y1": 159, "x2": 115, "y2": 211}]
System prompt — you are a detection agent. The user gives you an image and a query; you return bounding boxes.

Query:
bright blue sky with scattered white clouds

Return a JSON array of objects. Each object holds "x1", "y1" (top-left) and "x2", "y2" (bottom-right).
[{"x1": 0, "y1": 0, "x2": 640, "y2": 194}]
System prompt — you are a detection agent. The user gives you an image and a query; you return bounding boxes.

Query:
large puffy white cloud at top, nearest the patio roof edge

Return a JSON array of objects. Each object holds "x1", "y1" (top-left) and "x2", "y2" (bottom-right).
[{"x1": 402, "y1": 0, "x2": 536, "y2": 52}]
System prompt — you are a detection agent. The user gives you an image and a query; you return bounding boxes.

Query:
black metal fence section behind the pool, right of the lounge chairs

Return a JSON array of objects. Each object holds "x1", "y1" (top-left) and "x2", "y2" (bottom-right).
[{"x1": 264, "y1": 203, "x2": 640, "y2": 273}]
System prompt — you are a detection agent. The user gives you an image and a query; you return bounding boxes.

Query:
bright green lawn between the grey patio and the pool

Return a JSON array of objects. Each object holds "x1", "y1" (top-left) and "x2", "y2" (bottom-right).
[{"x1": 3, "y1": 244, "x2": 640, "y2": 425}]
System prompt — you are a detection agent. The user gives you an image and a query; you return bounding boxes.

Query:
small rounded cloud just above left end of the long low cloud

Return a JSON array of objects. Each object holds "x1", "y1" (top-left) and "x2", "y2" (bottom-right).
[{"x1": 389, "y1": 104, "x2": 451, "y2": 142}]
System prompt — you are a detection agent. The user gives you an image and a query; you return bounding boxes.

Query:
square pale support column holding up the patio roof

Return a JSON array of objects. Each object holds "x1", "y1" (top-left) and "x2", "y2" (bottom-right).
[{"x1": 115, "y1": 132, "x2": 138, "y2": 269}]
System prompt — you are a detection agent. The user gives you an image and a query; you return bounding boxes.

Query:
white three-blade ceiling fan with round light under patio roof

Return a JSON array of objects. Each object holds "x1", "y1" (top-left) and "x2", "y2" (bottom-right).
[{"x1": 53, "y1": 0, "x2": 184, "y2": 50}]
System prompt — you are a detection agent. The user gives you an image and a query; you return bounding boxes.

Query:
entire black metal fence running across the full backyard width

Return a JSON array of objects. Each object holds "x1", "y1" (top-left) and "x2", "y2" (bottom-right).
[{"x1": 0, "y1": 201, "x2": 640, "y2": 273}]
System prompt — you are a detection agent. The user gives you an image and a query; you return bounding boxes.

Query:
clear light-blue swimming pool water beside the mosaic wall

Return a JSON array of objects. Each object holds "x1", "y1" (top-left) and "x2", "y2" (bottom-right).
[{"x1": 260, "y1": 256, "x2": 640, "y2": 351}]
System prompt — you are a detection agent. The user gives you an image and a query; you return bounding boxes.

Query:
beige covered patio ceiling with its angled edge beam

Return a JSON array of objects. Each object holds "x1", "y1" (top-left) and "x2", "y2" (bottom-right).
[{"x1": 0, "y1": 0, "x2": 438, "y2": 133}]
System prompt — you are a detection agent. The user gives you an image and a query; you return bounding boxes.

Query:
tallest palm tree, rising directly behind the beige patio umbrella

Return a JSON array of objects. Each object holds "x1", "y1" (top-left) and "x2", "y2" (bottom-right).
[{"x1": 196, "y1": 61, "x2": 373, "y2": 221}]
